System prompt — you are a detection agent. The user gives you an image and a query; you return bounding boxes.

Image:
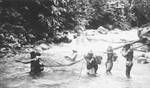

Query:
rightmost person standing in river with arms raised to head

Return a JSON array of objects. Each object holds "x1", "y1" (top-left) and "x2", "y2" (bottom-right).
[{"x1": 122, "y1": 44, "x2": 134, "y2": 78}]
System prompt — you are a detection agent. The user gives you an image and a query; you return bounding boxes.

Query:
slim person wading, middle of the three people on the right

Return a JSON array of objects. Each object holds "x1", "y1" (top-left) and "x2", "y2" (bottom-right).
[{"x1": 105, "y1": 46, "x2": 117, "y2": 75}]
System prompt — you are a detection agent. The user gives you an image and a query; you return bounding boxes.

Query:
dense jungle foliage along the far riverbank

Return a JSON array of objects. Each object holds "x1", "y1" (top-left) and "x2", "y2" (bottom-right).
[{"x1": 0, "y1": 0, "x2": 150, "y2": 54}]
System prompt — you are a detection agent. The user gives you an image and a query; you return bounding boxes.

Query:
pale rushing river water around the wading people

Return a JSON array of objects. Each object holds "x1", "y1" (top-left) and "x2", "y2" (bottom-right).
[{"x1": 0, "y1": 31, "x2": 150, "y2": 88}]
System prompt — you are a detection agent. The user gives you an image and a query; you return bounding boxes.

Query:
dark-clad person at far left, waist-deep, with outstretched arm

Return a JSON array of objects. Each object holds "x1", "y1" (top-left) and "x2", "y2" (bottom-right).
[{"x1": 16, "y1": 51, "x2": 44, "y2": 77}]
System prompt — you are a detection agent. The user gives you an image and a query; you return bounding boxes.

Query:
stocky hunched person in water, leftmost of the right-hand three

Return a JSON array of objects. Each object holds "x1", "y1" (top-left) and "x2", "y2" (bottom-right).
[{"x1": 85, "y1": 51, "x2": 98, "y2": 76}]
